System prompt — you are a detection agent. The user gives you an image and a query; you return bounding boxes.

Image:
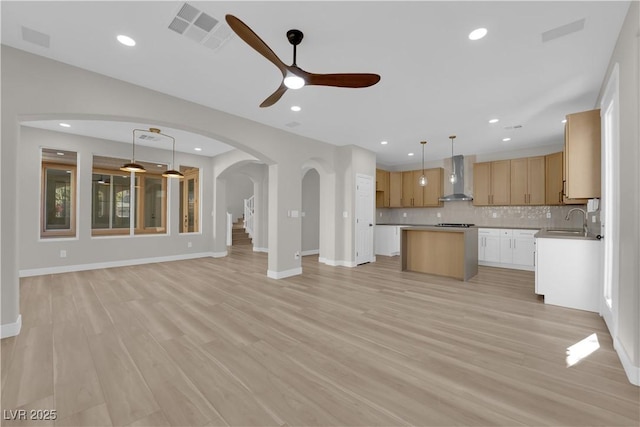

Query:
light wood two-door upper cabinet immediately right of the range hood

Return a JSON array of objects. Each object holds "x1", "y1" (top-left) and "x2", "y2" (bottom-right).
[{"x1": 473, "y1": 160, "x2": 511, "y2": 206}]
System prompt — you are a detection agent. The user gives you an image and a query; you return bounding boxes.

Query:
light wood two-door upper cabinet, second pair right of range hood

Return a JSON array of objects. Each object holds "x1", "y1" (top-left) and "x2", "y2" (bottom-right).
[{"x1": 510, "y1": 156, "x2": 545, "y2": 205}]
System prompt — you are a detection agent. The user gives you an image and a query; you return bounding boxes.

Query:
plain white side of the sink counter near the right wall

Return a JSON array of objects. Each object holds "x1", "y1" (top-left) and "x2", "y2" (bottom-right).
[{"x1": 536, "y1": 238, "x2": 602, "y2": 313}]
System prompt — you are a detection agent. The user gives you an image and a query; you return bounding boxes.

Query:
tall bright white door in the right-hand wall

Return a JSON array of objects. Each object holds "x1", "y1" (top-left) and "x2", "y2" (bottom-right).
[{"x1": 600, "y1": 64, "x2": 620, "y2": 337}]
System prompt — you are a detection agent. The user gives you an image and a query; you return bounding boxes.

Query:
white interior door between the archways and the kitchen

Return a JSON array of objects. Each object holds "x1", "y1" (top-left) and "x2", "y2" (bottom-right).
[{"x1": 356, "y1": 174, "x2": 375, "y2": 265}]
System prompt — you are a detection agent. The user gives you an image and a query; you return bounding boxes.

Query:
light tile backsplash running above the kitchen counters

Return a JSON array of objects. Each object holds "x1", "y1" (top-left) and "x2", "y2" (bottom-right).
[{"x1": 376, "y1": 202, "x2": 600, "y2": 234}]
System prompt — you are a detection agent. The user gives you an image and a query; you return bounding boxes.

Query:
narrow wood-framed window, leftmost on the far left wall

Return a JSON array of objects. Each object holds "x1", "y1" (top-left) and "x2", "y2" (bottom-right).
[{"x1": 40, "y1": 148, "x2": 77, "y2": 237}]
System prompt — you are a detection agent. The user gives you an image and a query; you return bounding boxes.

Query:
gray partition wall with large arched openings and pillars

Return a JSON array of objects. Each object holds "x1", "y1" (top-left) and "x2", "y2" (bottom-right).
[{"x1": 0, "y1": 46, "x2": 375, "y2": 332}]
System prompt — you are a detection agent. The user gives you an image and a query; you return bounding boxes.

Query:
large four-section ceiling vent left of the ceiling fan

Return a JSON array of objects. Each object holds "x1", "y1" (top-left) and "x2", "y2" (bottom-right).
[{"x1": 169, "y1": 3, "x2": 233, "y2": 50}]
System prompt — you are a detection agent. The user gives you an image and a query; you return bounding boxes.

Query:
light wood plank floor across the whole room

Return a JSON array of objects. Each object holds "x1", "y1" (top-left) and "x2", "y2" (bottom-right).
[{"x1": 1, "y1": 247, "x2": 640, "y2": 426}]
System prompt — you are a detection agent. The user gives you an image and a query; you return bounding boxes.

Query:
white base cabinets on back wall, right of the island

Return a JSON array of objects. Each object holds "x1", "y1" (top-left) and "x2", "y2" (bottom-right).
[{"x1": 478, "y1": 228, "x2": 538, "y2": 271}]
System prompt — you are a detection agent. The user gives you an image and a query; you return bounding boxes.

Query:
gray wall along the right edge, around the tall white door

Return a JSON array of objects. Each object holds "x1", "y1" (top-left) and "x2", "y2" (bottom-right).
[{"x1": 597, "y1": 1, "x2": 640, "y2": 375}]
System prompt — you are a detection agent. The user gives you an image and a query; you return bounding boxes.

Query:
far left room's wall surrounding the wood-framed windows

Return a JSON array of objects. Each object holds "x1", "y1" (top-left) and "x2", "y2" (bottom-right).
[{"x1": 16, "y1": 126, "x2": 212, "y2": 275}]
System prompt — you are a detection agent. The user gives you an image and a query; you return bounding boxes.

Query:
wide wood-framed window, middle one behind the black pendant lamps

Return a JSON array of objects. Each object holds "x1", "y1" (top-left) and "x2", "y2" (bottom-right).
[{"x1": 91, "y1": 156, "x2": 167, "y2": 236}]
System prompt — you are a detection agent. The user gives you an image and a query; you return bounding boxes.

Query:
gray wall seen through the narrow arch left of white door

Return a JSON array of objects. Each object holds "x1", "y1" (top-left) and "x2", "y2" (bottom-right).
[{"x1": 302, "y1": 169, "x2": 320, "y2": 253}]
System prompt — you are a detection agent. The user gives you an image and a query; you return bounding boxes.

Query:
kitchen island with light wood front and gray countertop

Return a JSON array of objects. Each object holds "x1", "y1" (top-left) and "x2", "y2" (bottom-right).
[{"x1": 400, "y1": 226, "x2": 478, "y2": 281}]
